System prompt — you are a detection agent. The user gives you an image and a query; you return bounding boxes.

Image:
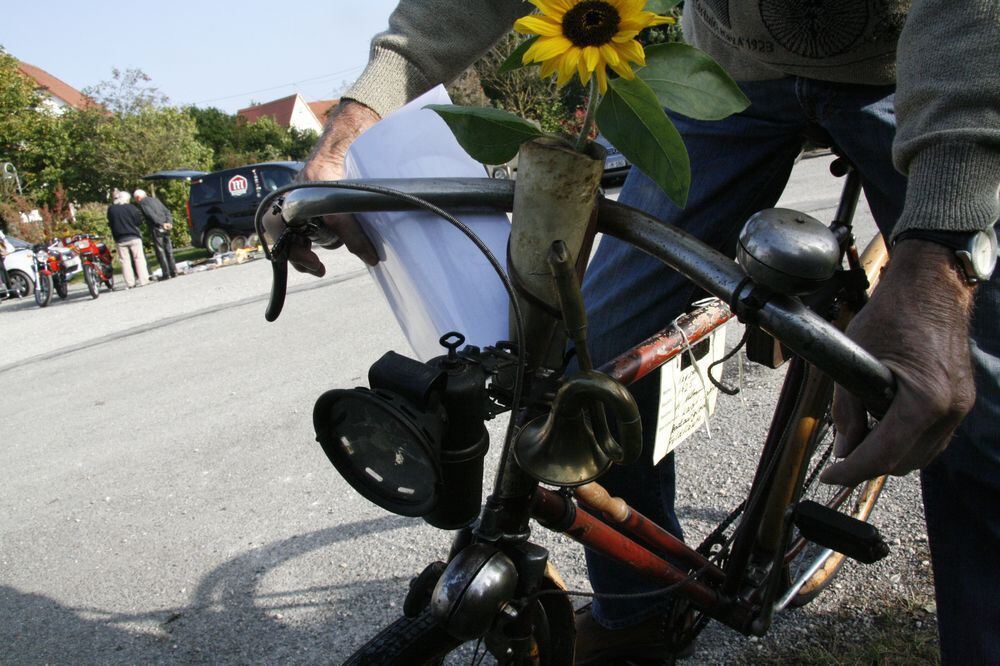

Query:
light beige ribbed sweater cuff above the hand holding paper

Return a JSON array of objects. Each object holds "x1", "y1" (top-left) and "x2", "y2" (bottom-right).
[{"x1": 343, "y1": 48, "x2": 434, "y2": 118}]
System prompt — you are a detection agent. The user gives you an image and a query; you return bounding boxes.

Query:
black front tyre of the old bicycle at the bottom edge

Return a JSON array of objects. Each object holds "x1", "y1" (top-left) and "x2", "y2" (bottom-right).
[{"x1": 344, "y1": 595, "x2": 575, "y2": 666}]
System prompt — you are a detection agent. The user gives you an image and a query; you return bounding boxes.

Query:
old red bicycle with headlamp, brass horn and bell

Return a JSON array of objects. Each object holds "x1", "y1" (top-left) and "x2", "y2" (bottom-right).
[{"x1": 257, "y1": 139, "x2": 894, "y2": 664}]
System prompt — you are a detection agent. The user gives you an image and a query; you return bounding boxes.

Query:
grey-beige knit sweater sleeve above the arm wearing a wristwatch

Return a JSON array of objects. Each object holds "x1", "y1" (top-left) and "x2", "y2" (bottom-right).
[{"x1": 893, "y1": 0, "x2": 1000, "y2": 234}]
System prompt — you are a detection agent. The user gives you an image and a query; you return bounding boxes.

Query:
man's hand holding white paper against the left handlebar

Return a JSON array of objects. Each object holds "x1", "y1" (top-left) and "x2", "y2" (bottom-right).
[{"x1": 264, "y1": 100, "x2": 379, "y2": 277}]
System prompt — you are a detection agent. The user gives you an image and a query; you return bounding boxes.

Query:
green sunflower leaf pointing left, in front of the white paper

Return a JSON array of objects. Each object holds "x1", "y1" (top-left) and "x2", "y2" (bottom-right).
[{"x1": 424, "y1": 104, "x2": 542, "y2": 164}]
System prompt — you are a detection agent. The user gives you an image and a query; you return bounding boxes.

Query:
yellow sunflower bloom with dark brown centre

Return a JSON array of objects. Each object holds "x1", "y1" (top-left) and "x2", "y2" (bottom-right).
[{"x1": 514, "y1": 0, "x2": 674, "y2": 94}]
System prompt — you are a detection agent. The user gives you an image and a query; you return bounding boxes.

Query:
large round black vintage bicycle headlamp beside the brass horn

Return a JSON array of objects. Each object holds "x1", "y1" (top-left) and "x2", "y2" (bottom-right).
[{"x1": 313, "y1": 336, "x2": 489, "y2": 529}]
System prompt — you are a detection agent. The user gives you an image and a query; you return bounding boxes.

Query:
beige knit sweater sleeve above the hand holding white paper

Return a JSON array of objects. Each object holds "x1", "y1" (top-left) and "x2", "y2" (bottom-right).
[{"x1": 344, "y1": 0, "x2": 532, "y2": 117}]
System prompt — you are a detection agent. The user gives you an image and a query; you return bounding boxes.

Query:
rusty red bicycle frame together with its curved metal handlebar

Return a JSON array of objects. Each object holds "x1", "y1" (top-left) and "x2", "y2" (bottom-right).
[{"x1": 270, "y1": 163, "x2": 893, "y2": 634}]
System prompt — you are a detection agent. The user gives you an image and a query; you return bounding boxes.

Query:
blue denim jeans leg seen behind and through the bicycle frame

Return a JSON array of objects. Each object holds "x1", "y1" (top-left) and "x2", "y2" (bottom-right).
[{"x1": 583, "y1": 80, "x2": 804, "y2": 628}]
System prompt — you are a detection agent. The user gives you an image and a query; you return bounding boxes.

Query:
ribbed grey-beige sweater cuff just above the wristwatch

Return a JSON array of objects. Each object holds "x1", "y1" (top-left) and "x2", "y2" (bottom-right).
[{"x1": 892, "y1": 142, "x2": 1000, "y2": 239}]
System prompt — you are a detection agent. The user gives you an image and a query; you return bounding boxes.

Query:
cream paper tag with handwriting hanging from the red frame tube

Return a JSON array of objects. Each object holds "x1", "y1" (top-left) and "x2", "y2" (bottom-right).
[{"x1": 653, "y1": 324, "x2": 728, "y2": 465}]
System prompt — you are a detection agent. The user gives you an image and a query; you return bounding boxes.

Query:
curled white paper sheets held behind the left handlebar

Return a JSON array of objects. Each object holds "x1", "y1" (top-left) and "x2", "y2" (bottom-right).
[{"x1": 345, "y1": 86, "x2": 510, "y2": 360}]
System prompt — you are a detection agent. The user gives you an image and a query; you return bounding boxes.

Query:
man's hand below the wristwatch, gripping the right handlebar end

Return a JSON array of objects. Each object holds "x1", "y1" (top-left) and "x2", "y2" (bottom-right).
[{"x1": 820, "y1": 239, "x2": 976, "y2": 486}]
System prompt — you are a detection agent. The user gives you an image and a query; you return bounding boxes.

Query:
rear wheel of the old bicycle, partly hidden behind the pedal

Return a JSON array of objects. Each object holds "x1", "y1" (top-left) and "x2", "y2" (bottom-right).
[{"x1": 784, "y1": 236, "x2": 889, "y2": 608}]
